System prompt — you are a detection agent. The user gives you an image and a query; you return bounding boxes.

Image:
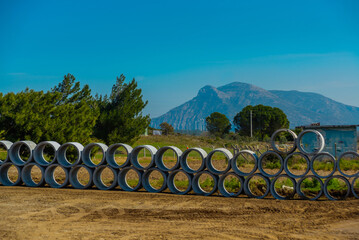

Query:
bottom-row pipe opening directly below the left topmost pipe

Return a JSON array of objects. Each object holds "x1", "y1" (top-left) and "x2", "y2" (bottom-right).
[{"x1": 270, "y1": 174, "x2": 297, "y2": 200}]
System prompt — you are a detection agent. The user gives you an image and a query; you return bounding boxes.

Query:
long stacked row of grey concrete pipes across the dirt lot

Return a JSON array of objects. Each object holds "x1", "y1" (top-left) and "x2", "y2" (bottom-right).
[{"x1": 0, "y1": 129, "x2": 359, "y2": 200}]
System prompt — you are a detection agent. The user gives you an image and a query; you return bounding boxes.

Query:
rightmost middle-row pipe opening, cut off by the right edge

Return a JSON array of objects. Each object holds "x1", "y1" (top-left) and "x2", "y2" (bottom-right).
[{"x1": 337, "y1": 152, "x2": 359, "y2": 178}]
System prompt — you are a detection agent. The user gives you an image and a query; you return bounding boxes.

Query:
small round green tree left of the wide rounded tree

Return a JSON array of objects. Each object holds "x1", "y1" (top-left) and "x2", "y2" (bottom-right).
[{"x1": 206, "y1": 112, "x2": 231, "y2": 137}]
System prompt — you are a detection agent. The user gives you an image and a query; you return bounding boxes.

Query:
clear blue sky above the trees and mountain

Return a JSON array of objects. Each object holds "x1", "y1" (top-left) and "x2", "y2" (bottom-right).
[{"x1": 0, "y1": 0, "x2": 359, "y2": 117}]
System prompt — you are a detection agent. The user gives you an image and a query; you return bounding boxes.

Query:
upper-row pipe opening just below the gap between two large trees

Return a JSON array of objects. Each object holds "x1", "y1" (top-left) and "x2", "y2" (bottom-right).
[{"x1": 82, "y1": 143, "x2": 108, "y2": 168}]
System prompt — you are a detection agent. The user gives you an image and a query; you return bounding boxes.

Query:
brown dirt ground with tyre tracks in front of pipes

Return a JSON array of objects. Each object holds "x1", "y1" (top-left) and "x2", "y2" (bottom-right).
[{"x1": 0, "y1": 186, "x2": 359, "y2": 239}]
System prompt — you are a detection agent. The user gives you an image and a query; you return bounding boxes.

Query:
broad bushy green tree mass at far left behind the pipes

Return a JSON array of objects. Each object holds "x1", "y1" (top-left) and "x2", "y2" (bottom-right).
[{"x1": 0, "y1": 74, "x2": 99, "y2": 144}]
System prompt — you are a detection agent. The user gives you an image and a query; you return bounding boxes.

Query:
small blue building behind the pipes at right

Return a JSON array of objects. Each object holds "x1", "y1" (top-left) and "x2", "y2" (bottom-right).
[{"x1": 297, "y1": 123, "x2": 359, "y2": 158}]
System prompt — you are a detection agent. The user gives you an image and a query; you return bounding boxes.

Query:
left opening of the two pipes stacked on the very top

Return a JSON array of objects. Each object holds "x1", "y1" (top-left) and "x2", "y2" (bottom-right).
[{"x1": 271, "y1": 129, "x2": 297, "y2": 154}]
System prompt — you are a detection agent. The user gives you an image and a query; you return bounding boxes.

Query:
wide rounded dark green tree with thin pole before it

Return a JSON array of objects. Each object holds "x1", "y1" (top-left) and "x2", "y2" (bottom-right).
[{"x1": 233, "y1": 104, "x2": 289, "y2": 139}]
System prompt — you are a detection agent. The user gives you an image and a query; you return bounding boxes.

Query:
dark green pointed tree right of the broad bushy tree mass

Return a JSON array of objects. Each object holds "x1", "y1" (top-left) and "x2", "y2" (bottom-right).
[{"x1": 95, "y1": 74, "x2": 150, "y2": 144}]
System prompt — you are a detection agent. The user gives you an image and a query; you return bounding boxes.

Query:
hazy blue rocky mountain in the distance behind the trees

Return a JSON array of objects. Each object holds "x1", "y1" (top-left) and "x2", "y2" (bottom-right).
[{"x1": 151, "y1": 82, "x2": 359, "y2": 130}]
